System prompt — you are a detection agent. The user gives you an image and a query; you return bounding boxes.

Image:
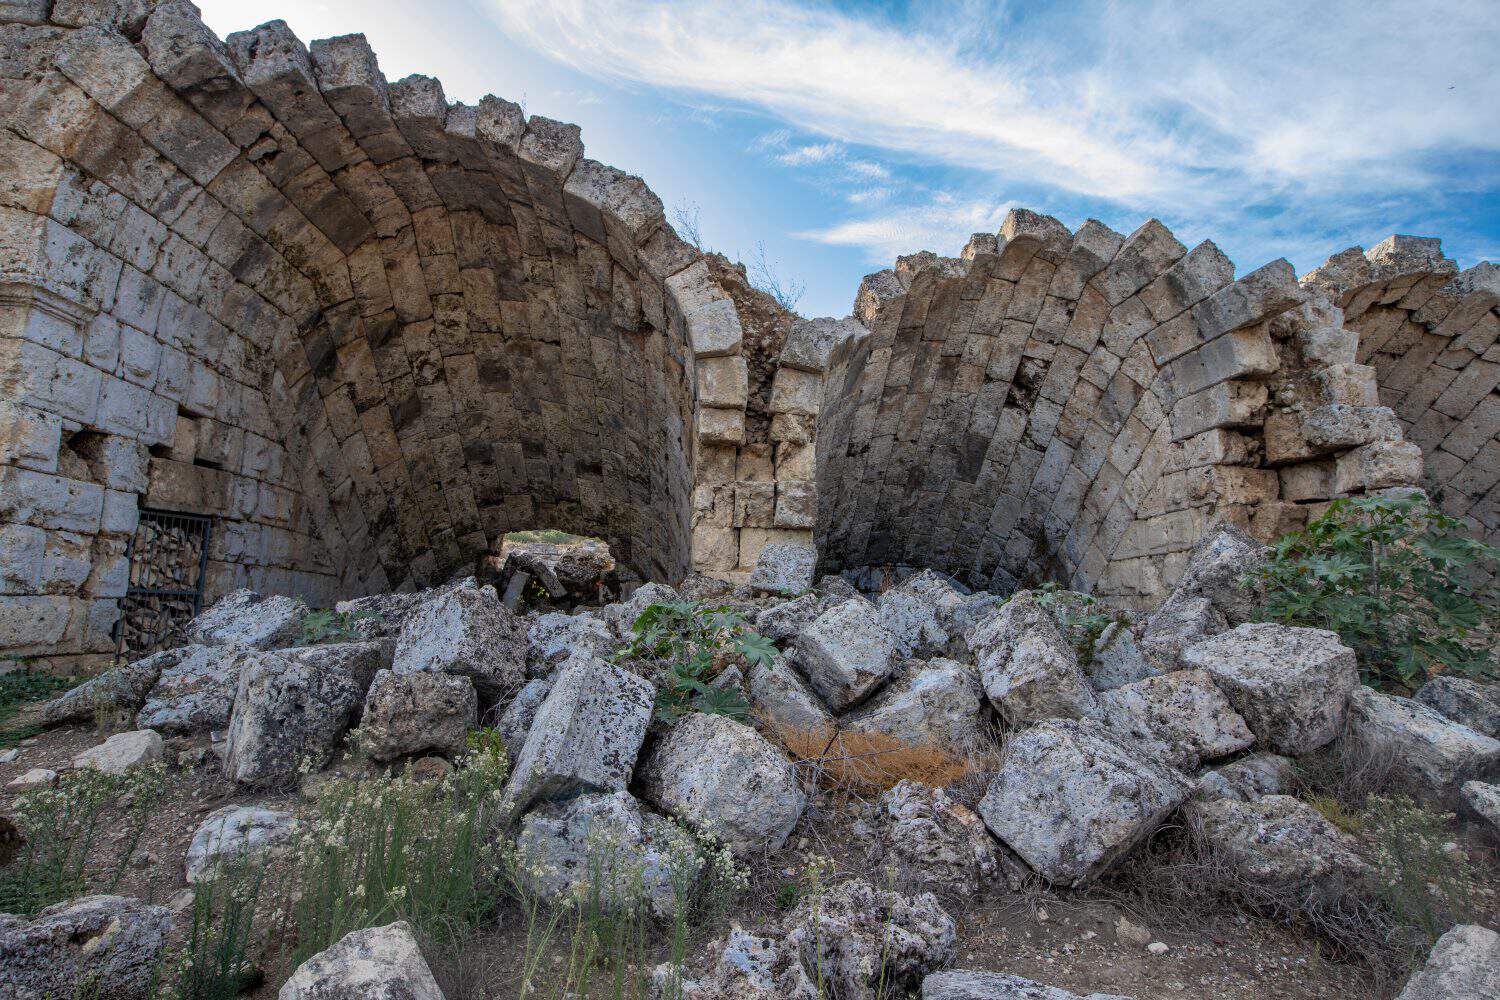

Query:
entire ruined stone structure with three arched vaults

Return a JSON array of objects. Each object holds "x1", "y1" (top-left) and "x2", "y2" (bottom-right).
[{"x1": 0, "y1": 0, "x2": 1500, "y2": 667}]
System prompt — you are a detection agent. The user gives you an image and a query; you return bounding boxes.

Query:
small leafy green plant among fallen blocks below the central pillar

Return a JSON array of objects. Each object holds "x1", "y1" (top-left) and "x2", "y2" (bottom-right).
[{"x1": 615, "y1": 601, "x2": 776, "y2": 724}]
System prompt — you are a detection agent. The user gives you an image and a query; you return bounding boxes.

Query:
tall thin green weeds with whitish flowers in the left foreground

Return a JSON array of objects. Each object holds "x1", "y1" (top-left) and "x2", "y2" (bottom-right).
[{"x1": 290, "y1": 736, "x2": 507, "y2": 963}]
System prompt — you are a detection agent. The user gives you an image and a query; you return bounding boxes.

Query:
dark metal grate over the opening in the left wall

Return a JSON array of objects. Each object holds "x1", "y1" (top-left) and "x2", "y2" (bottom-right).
[{"x1": 114, "y1": 510, "x2": 213, "y2": 663}]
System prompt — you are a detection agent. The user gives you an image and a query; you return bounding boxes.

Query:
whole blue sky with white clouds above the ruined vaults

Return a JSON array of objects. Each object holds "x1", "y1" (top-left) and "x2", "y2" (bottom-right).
[{"x1": 198, "y1": 0, "x2": 1500, "y2": 315}]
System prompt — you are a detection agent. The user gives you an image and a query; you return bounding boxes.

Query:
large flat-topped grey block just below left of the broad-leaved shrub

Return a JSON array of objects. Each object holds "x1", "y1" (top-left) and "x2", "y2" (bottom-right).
[{"x1": 1182, "y1": 624, "x2": 1359, "y2": 756}]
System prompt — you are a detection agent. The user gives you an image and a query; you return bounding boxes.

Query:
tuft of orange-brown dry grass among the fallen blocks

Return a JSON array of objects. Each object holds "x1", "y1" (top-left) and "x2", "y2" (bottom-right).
[{"x1": 771, "y1": 726, "x2": 969, "y2": 796}]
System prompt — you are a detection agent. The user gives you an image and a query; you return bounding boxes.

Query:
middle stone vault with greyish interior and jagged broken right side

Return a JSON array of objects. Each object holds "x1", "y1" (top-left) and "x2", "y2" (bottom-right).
[{"x1": 818, "y1": 211, "x2": 1421, "y2": 604}]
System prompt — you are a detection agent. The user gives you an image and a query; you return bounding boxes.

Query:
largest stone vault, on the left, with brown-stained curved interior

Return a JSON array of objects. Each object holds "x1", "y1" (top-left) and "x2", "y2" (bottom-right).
[{"x1": 0, "y1": 0, "x2": 713, "y2": 668}]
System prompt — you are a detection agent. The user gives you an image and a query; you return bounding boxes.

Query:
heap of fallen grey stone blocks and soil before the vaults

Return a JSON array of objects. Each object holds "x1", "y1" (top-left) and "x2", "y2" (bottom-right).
[{"x1": 0, "y1": 529, "x2": 1500, "y2": 1000}]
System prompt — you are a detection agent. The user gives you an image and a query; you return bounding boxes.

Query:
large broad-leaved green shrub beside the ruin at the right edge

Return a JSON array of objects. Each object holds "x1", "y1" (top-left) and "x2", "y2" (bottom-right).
[{"x1": 1250, "y1": 493, "x2": 1500, "y2": 691}]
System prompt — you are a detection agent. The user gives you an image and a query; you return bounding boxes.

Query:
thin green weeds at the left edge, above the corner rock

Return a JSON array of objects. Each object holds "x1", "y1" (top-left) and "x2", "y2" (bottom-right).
[{"x1": 0, "y1": 765, "x2": 165, "y2": 915}]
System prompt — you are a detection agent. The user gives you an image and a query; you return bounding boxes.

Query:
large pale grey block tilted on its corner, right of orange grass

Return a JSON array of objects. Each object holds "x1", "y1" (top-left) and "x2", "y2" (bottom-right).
[{"x1": 980, "y1": 720, "x2": 1193, "y2": 886}]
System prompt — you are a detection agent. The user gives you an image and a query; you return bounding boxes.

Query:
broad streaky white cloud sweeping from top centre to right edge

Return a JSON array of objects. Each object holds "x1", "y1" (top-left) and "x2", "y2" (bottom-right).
[{"x1": 491, "y1": 0, "x2": 1500, "y2": 210}]
